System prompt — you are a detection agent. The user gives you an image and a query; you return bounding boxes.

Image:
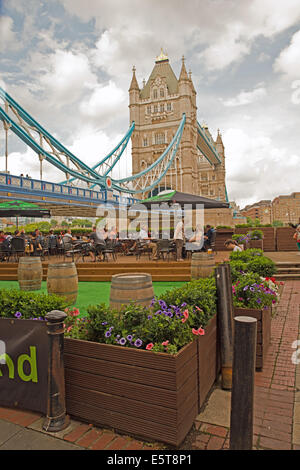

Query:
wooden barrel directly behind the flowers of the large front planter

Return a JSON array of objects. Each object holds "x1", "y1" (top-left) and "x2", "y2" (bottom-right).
[{"x1": 109, "y1": 273, "x2": 154, "y2": 310}]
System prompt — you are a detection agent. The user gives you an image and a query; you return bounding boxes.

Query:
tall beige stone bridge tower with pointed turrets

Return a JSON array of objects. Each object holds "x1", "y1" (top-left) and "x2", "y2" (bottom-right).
[{"x1": 129, "y1": 51, "x2": 226, "y2": 200}]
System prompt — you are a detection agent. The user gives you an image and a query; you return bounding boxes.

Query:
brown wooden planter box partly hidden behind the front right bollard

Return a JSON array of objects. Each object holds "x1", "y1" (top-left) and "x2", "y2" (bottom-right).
[{"x1": 234, "y1": 307, "x2": 271, "y2": 370}]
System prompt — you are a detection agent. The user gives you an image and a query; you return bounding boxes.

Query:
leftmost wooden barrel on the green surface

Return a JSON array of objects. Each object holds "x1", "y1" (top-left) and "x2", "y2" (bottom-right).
[{"x1": 18, "y1": 256, "x2": 43, "y2": 290}]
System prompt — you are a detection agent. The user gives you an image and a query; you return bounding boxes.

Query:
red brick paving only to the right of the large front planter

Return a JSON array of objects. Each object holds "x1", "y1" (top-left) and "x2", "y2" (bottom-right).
[{"x1": 193, "y1": 281, "x2": 300, "y2": 450}]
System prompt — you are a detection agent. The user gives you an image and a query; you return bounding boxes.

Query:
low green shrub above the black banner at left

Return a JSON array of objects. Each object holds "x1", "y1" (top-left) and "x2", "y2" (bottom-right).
[{"x1": 0, "y1": 289, "x2": 67, "y2": 319}]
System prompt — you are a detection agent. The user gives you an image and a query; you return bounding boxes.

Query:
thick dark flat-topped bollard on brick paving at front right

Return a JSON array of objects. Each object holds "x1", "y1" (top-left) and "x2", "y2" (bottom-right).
[{"x1": 230, "y1": 317, "x2": 257, "y2": 450}]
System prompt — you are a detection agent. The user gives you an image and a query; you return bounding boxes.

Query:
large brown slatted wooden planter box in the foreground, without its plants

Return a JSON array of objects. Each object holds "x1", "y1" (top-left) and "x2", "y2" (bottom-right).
[{"x1": 64, "y1": 317, "x2": 217, "y2": 446}]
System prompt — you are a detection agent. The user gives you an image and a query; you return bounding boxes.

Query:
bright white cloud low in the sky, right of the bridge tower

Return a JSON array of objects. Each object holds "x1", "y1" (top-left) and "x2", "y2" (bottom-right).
[{"x1": 223, "y1": 128, "x2": 300, "y2": 206}]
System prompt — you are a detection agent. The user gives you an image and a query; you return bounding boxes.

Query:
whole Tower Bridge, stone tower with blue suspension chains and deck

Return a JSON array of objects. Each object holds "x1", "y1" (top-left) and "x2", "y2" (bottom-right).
[{"x1": 0, "y1": 51, "x2": 228, "y2": 220}]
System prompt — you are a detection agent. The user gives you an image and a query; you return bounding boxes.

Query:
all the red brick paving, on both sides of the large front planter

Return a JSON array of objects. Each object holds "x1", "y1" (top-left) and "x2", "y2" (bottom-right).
[{"x1": 0, "y1": 281, "x2": 300, "y2": 450}]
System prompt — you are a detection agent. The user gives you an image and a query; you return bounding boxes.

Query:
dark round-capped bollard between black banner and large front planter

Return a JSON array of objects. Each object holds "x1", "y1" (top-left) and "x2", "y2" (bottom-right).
[{"x1": 43, "y1": 310, "x2": 69, "y2": 432}]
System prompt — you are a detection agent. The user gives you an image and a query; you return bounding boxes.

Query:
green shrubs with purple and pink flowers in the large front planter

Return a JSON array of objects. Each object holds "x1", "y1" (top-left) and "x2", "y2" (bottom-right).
[{"x1": 70, "y1": 277, "x2": 216, "y2": 354}]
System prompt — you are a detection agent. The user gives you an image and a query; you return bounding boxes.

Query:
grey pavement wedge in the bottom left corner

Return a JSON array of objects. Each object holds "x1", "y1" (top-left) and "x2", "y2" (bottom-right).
[{"x1": 0, "y1": 419, "x2": 84, "y2": 450}]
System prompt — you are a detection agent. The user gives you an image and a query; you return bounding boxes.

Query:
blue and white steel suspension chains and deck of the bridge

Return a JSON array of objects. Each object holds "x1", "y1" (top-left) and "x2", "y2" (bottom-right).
[{"x1": 0, "y1": 87, "x2": 228, "y2": 214}]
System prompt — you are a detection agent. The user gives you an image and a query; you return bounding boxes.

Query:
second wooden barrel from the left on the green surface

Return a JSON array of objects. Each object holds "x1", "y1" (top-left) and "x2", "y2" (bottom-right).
[{"x1": 47, "y1": 263, "x2": 78, "y2": 304}]
